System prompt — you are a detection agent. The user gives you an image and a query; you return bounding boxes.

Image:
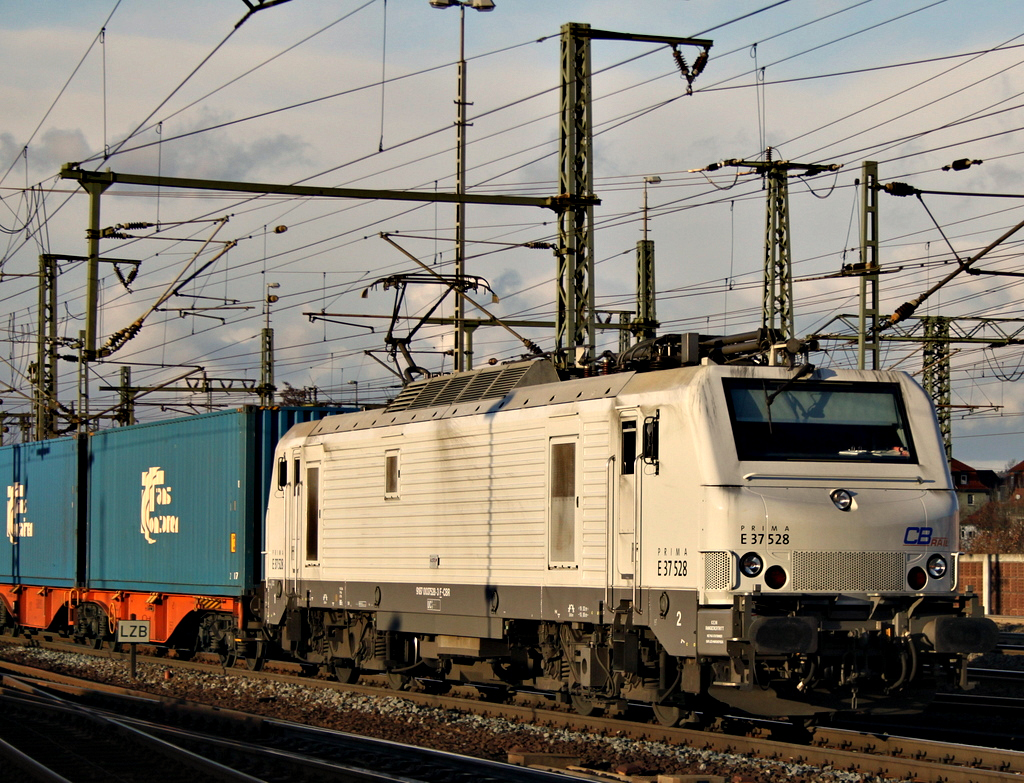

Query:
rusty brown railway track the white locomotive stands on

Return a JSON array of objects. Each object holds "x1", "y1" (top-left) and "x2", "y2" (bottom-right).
[{"x1": 2, "y1": 645, "x2": 1024, "y2": 783}]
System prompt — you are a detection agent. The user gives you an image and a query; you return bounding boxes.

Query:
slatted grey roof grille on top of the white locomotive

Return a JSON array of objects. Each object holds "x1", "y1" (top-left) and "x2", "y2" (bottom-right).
[{"x1": 387, "y1": 361, "x2": 558, "y2": 412}]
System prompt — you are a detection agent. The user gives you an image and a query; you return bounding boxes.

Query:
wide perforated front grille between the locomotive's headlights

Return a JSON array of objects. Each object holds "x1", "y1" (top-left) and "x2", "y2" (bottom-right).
[{"x1": 791, "y1": 552, "x2": 906, "y2": 593}]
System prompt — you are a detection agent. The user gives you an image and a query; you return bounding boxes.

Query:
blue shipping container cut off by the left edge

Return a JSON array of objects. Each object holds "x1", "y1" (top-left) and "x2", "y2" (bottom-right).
[{"x1": 0, "y1": 437, "x2": 80, "y2": 588}]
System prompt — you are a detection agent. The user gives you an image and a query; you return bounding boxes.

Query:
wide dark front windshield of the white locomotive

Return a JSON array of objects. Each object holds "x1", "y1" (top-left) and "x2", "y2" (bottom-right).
[{"x1": 724, "y1": 379, "x2": 916, "y2": 464}]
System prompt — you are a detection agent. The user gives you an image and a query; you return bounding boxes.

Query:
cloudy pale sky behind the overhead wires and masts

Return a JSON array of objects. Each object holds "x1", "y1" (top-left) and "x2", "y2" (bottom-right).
[{"x1": 0, "y1": 0, "x2": 1024, "y2": 468}]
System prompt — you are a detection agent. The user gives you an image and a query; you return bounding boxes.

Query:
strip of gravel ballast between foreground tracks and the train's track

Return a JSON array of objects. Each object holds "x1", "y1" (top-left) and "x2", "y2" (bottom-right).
[{"x1": 0, "y1": 644, "x2": 909, "y2": 783}]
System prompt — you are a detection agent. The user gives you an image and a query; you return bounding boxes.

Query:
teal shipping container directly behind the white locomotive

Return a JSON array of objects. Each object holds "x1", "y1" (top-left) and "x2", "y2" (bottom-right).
[{"x1": 86, "y1": 406, "x2": 340, "y2": 596}]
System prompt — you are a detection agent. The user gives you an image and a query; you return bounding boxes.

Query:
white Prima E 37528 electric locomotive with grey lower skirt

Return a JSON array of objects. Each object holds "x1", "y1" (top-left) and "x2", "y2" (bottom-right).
[{"x1": 263, "y1": 336, "x2": 996, "y2": 724}]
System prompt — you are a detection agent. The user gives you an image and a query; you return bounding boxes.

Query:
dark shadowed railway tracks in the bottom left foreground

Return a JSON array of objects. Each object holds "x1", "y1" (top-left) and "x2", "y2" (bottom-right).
[{"x1": 0, "y1": 675, "x2": 577, "y2": 783}]
